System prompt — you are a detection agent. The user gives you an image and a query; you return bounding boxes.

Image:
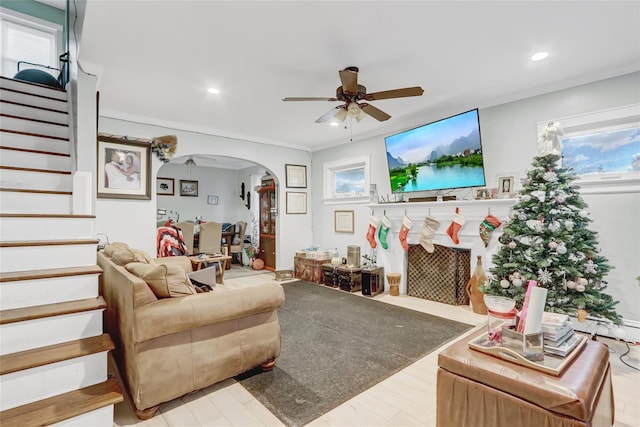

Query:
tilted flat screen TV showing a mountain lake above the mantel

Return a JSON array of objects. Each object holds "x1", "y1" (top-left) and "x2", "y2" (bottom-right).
[{"x1": 385, "y1": 109, "x2": 485, "y2": 193}]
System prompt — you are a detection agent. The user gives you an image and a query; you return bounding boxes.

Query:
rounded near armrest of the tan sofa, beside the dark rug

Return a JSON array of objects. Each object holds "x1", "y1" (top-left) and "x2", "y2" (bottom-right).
[{"x1": 134, "y1": 283, "x2": 284, "y2": 343}]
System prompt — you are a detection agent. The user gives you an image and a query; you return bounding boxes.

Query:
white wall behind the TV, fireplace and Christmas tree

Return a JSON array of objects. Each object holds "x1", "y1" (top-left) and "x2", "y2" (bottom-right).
[{"x1": 311, "y1": 73, "x2": 640, "y2": 319}]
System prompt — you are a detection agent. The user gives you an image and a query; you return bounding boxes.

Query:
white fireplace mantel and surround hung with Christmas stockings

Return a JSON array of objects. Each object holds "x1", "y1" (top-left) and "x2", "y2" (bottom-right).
[{"x1": 368, "y1": 199, "x2": 517, "y2": 294}]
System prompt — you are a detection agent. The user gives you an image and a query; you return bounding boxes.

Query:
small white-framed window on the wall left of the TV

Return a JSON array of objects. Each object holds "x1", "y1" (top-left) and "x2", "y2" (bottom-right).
[{"x1": 323, "y1": 156, "x2": 370, "y2": 203}]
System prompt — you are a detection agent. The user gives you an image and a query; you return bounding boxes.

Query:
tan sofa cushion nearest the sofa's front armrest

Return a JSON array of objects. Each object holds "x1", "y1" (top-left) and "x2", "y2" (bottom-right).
[{"x1": 125, "y1": 262, "x2": 196, "y2": 298}]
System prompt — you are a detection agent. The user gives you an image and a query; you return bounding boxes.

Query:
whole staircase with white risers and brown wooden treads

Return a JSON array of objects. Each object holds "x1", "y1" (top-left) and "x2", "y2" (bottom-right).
[{"x1": 0, "y1": 77, "x2": 122, "y2": 427}]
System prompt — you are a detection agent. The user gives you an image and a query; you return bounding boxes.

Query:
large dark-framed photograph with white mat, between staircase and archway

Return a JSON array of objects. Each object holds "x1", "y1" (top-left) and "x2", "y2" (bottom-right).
[{"x1": 96, "y1": 134, "x2": 151, "y2": 200}]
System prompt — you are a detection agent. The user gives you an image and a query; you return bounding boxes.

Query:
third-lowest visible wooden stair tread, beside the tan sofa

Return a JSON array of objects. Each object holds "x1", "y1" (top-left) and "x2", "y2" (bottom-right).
[{"x1": 0, "y1": 296, "x2": 107, "y2": 325}]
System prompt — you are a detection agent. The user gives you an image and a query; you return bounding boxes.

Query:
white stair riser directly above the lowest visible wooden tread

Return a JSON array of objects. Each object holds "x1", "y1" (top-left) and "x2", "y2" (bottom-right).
[{"x1": 0, "y1": 352, "x2": 107, "y2": 411}]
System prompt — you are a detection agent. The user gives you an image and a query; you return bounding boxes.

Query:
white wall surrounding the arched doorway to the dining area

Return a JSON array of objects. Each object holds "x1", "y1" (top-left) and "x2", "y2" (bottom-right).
[{"x1": 78, "y1": 72, "x2": 312, "y2": 269}]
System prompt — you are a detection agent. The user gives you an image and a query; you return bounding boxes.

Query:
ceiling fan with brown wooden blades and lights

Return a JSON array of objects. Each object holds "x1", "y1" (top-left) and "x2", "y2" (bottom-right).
[{"x1": 282, "y1": 67, "x2": 424, "y2": 123}]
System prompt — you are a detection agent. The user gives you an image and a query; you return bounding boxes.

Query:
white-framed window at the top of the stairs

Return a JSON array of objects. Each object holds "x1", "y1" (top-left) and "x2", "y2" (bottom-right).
[{"x1": 0, "y1": 9, "x2": 62, "y2": 77}]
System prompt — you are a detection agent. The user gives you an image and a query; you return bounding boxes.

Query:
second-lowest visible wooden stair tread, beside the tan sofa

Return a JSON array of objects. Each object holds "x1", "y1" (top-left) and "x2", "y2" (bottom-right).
[{"x1": 0, "y1": 333, "x2": 115, "y2": 375}]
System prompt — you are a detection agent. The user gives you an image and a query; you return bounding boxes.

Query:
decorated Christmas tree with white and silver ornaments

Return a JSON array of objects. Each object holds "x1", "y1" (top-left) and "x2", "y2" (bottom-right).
[{"x1": 483, "y1": 124, "x2": 622, "y2": 325}]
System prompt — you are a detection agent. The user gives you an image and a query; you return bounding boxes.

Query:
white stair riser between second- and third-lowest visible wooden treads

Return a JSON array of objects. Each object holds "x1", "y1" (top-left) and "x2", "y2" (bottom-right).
[{"x1": 0, "y1": 310, "x2": 103, "y2": 355}]
